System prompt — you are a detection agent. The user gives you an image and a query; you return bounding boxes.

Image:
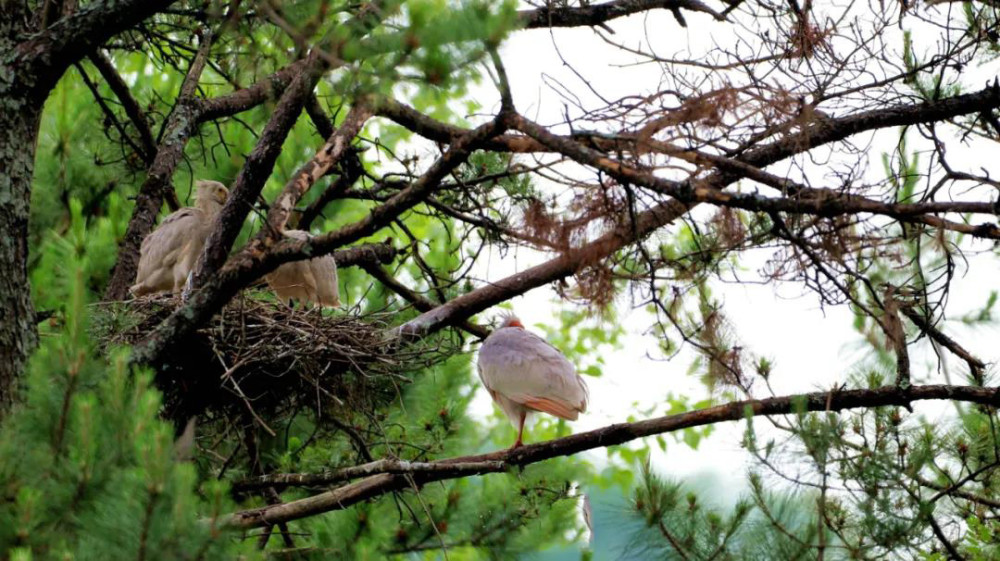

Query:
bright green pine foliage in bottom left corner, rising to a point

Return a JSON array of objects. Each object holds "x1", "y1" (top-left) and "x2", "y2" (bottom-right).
[{"x1": 0, "y1": 212, "x2": 242, "y2": 560}]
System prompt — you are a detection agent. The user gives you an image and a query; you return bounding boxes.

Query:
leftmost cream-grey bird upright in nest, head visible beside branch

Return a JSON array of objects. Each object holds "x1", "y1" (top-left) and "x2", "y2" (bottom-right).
[{"x1": 129, "y1": 180, "x2": 229, "y2": 296}]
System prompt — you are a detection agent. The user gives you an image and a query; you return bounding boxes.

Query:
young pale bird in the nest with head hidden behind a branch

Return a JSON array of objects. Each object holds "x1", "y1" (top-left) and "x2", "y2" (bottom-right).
[{"x1": 264, "y1": 230, "x2": 340, "y2": 308}]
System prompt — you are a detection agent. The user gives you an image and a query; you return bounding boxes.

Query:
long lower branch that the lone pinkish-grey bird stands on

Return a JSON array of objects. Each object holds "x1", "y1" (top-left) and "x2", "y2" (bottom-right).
[{"x1": 221, "y1": 385, "x2": 1000, "y2": 529}]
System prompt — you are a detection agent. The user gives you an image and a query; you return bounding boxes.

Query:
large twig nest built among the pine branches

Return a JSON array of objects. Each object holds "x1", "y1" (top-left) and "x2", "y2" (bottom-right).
[{"x1": 95, "y1": 294, "x2": 449, "y2": 432}]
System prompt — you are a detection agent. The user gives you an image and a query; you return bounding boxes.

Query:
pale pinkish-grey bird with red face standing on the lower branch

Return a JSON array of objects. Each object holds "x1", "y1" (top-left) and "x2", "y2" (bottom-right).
[{"x1": 479, "y1": 316, "x2": 588, "y2": 448}]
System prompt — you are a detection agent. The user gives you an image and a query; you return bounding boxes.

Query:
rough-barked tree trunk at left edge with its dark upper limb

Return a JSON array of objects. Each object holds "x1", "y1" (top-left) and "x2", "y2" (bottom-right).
[{"x1": 0, "y1": 0, "x2": 175, "y2": 404}]
